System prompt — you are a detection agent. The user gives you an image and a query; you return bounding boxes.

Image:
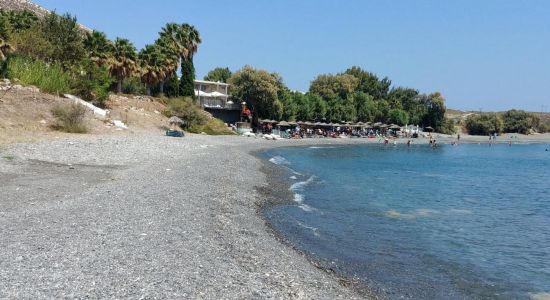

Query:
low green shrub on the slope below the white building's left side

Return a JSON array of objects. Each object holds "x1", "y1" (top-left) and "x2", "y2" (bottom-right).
[{"x1": 164, "y1": 97, "x2": 208, "y2": 127}]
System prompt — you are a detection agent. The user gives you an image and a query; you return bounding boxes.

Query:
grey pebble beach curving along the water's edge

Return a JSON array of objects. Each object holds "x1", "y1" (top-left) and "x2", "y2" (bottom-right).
[{"x1": 0, "y1": 134, "x2": 384, "y2": 299}]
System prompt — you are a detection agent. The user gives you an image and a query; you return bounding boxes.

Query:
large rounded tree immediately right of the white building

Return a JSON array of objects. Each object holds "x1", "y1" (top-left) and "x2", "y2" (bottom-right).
[{"x1": 229, "y1": 66, "x2": 279, "y2": 123}]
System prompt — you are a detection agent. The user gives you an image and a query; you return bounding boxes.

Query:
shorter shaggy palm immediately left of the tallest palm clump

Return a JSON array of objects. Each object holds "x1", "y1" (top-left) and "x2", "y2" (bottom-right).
[{"x1": 138, "y1": 44, "x2": 166, "y2": 96}]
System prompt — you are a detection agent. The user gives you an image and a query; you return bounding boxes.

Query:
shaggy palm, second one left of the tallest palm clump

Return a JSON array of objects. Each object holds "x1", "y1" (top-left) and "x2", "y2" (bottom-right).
[{"x1": 108, "y1": 38, "x2": 137, "y2": 93}]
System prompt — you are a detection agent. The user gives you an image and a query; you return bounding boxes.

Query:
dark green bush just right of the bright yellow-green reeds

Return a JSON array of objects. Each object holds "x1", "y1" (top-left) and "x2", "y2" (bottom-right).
[{"x1": 72, "y1": 60, "x2": 113, "y2": 107}]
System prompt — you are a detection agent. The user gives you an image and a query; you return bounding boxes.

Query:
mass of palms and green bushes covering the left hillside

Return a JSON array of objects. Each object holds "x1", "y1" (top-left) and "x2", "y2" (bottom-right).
[{"x1": 0, "y1": 10, "x2": 201, "y2": 105}]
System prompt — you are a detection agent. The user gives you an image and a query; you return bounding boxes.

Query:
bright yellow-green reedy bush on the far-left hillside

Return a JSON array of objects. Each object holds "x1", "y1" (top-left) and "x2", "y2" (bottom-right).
[{"x1": 7, "y1": 56, "x2": 71, "y2": 93}]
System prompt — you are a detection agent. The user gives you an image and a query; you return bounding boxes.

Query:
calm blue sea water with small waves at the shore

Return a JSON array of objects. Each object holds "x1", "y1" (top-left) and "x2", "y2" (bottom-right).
[{"x1": 264, "y1": 144, "x2": 550, "y2": 299}]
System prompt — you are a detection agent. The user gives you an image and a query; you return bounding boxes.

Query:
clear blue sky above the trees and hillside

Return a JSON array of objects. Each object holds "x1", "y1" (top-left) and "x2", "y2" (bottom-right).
[{"x1": 35, "y1": 0, "x2": 550, "y2": 111}]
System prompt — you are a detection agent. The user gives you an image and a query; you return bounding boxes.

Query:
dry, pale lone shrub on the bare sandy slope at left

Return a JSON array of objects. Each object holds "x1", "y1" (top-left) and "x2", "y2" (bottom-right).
[{"x1": 51, "y1": 103, "x2": 88, "y2": 133}]
